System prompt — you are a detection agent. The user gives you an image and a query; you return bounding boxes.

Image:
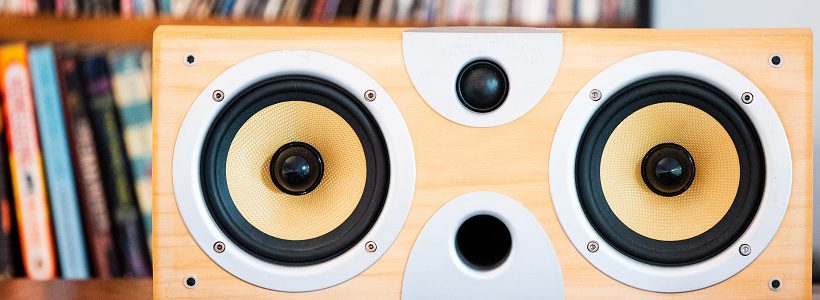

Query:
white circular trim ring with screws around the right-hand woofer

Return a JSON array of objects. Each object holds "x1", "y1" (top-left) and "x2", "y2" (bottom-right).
[{"x1": 549, "y1": 51, "x2": 792, "y2": 293}]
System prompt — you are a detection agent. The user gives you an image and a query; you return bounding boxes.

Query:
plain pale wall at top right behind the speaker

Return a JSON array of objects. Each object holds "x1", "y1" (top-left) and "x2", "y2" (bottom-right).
[{"x1": 651, "y1": 0, "x2": 820, "y2": 278}]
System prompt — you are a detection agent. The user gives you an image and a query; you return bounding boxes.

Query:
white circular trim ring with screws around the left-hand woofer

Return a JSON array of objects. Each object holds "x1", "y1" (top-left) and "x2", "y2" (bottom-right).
[{"x1": 172, "y1": 50, "x2": 416, "y2": 292}]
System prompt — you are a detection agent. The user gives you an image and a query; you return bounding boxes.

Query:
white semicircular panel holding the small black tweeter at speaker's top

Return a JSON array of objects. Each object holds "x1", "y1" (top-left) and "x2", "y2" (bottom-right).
[{"x1": 402, "y1": 27, "x2": 563, "y2": 127}]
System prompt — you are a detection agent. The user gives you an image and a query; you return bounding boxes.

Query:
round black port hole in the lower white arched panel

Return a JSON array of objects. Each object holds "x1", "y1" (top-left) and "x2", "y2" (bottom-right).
[{"x1": 456, "y1": 215, "x2": 512, "y2": 271}]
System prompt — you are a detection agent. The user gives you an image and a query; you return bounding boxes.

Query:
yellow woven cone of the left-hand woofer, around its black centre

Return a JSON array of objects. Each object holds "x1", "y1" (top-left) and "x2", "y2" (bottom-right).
[{"x1": 225, "y1": 101, "x2": 367, "y2": 240}]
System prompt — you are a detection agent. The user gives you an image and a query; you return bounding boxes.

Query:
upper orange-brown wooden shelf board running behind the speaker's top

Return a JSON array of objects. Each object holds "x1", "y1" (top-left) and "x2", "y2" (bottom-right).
[{"x1": 0, "y1": 16, "x2": 634, "y2": 47}]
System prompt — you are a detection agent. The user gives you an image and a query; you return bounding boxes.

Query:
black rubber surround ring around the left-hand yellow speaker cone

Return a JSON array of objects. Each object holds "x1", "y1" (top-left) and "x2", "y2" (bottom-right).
[{"x1": 200, "y1": 76, "x2": 390, "y2": 265}]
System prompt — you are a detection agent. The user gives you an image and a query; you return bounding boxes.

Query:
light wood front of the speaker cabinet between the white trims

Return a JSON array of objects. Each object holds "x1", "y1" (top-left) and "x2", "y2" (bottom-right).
[{"x1": 153, "y1": 26, "x2": 812, "y2": 299}]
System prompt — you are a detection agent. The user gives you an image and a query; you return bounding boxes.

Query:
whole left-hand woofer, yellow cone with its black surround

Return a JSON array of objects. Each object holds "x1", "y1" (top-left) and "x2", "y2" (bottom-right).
[{"x1": 201, "y1": 76, "x2": 389, "y2": 264}]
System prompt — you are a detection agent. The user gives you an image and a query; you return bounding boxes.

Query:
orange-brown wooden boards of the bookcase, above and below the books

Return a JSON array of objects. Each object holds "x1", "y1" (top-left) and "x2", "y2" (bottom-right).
[{"x1": 0, "y1": 0, "x2": 649, "y2": 299}]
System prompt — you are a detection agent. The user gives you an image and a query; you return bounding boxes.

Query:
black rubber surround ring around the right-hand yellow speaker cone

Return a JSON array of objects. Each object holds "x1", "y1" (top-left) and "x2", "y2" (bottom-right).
[{"x1": 575, "y1": 76, "x2": 766, "y2": 266}]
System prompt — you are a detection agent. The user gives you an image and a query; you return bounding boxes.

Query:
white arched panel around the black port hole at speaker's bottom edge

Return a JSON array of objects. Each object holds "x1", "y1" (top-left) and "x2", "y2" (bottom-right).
[{"x1": 402, "y1": 192, "x2": 565, "y2": 299}]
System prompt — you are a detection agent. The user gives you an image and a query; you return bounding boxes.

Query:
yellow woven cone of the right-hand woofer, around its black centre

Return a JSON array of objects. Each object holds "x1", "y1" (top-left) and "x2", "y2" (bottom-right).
[{"x1": 600, "y1": 102, "x2": 740, "y2": 241}]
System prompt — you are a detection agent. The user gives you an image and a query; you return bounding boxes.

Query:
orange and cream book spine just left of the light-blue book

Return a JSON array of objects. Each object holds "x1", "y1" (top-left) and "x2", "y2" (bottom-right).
[{"x1": 0, "y1": 44, "x2": 57, "y2": 279}]
